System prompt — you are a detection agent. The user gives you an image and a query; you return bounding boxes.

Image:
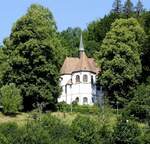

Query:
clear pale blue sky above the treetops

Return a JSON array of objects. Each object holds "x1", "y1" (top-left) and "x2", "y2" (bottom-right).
[{"x1": 0, "y1": 0, "x2": 150, "y2": 44}]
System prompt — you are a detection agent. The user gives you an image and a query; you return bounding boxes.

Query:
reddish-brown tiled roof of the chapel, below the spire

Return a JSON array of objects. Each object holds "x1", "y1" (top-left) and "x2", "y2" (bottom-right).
[{"x1": 61, "y1": 51, "x2": 100, "y2": 74}]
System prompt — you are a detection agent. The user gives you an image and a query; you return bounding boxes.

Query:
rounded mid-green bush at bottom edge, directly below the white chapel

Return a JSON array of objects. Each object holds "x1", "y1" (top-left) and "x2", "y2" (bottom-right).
[{"x1": 71, "y1": 115, "x2": 99, "y2": 144}]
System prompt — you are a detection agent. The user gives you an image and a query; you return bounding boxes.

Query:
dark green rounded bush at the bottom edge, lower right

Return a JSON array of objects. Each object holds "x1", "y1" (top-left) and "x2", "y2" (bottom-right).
[{"x1": 113, "y1": 118, "x2": 141, "y2": 144}]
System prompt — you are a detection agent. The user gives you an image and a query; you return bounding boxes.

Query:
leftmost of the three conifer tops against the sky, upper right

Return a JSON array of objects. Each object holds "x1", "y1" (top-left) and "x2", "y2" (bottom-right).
[{"x1": 112, "y1": 0, "x2": 122, "y2": 14}]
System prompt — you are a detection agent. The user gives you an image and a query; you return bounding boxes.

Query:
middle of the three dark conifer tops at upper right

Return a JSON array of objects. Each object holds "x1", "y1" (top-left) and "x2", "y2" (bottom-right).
[{"x1": 123, "y1": 0, "x2": 134, "y2": 18}]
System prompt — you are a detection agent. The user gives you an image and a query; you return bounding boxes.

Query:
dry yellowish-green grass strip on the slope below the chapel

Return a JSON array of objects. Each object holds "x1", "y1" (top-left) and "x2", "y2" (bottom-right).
[{"x1": 0, "y1": 106, "x2": 117, "y2": 127}]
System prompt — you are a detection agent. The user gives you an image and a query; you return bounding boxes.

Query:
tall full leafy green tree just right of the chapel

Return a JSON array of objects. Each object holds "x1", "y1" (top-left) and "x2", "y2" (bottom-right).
[{"x1": 96, "y1": 18, "x2": 145, "y2": 106}]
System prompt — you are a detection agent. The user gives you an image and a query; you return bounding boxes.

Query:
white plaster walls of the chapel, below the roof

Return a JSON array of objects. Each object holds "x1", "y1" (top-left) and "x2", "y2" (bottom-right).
[{"x1": 58, "y1": 72, "x2": 102, "y2": 105}]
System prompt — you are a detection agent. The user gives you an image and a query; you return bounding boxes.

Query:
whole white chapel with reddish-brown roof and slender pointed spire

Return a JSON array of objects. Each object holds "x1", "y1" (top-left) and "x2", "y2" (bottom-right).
[{"x1": 58, "y1": 35, "x2": 103, "y2": 105}]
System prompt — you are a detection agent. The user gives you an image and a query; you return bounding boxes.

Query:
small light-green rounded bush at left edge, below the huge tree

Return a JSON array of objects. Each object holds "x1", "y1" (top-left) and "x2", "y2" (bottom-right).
[{"x1": 0, "y1": 84, "x2": 23, "y2": 114}]
